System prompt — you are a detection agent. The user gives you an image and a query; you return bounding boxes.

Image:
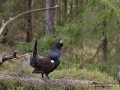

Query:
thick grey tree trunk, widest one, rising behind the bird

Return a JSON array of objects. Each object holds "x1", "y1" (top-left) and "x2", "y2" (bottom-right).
[{"x1": 46, "y1": 0, "x2": 56, "y2": 35}]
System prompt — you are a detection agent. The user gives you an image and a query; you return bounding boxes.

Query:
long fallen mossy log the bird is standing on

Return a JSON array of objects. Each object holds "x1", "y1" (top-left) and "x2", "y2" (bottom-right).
[{"x1": 0, "y1": 73, "x2": 111, "y2": 88}]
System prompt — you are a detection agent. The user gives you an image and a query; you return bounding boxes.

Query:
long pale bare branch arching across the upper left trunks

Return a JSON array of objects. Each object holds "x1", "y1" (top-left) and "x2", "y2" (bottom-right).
[{"x1": 0, "y1": 4, "x2": 62, "y2": 35}]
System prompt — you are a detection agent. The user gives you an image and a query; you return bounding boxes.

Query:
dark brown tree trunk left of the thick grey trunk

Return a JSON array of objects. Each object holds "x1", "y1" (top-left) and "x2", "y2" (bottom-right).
[{"x1": 26, "y1": 0, "x2": 33, "y2": 42}]
